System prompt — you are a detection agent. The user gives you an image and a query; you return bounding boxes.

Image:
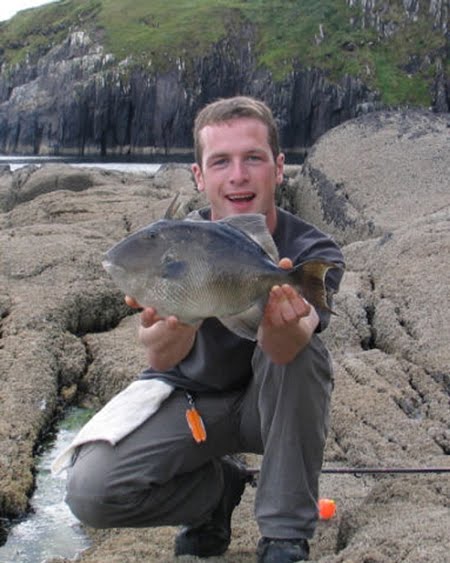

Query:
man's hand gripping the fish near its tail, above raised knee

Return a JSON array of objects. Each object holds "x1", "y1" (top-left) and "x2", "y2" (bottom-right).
[{"x1": 258, "y1": 258, "x2": 319, "y2": 364}]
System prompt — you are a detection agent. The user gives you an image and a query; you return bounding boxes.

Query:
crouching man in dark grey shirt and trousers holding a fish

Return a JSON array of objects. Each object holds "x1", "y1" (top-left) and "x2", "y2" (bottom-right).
[{"x1": 67, "y1": 96, "x2": 343, "y2": 563}]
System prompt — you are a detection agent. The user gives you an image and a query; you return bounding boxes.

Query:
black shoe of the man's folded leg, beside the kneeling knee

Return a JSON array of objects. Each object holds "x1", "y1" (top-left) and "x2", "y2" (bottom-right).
[{"x1": 175, "y1": 456, "x2": 252, "y2": 557}]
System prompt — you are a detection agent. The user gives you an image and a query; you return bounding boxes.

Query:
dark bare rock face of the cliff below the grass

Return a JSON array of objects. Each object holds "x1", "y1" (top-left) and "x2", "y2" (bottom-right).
[{"x1": 0, "y1": 29, "x2": 376, "y2": 155}]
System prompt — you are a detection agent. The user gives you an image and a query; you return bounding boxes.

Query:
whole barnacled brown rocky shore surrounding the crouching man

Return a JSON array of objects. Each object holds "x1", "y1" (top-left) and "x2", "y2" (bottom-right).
[{"x1": 0, "y1": 112, "x2": 450, "y2": 563}]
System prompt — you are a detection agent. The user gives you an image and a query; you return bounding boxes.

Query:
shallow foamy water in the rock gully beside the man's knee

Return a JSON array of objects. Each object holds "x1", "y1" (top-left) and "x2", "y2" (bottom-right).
[{"x1": 0, "y1": 408, "x2": 92, "y2": 563}]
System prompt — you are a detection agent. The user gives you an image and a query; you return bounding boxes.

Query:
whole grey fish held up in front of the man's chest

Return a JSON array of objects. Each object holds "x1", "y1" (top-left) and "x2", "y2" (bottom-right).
[{"x1": 102, "y1": 213, "x2": 340, "y2": 340}]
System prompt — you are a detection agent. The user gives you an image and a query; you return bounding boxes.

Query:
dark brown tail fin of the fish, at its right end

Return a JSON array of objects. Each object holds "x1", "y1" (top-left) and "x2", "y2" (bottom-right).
[{"x1": 288, "y1": 260, "x2": 342, "y2": 315}]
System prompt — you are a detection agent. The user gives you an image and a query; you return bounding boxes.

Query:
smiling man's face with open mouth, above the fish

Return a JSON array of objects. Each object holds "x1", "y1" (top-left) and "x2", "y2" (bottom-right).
[{"x1": 192, "y1": 117, "x2": 284, "y2": 232}]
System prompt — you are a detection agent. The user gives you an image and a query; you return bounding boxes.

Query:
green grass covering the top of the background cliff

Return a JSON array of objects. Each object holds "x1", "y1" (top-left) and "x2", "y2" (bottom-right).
[{"x1": 0, "y1": 0, "x2": 445, "y2": 105}]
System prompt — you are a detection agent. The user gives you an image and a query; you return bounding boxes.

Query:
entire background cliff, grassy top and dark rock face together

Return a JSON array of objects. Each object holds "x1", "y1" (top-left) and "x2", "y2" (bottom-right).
[{"x1": 0, "y1": 0, "x2": 450, "y2": 155}]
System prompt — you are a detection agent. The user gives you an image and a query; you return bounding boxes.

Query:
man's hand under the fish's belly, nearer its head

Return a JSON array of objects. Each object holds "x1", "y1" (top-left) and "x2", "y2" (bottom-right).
[{"x1": 125, "y1": 296, "x2": 201, "y2": 371}]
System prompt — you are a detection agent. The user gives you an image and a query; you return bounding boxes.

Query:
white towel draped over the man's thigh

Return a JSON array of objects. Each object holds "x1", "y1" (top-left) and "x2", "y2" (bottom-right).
[{"x1": 52, "y1": 379, "x2": 173, "y2": 475}]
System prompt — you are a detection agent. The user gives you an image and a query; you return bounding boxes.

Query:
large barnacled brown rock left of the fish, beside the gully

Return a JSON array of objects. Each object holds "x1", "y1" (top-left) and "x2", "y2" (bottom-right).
[{"x1": 0, "y1": 165, "x2": 199, "y2": 516}]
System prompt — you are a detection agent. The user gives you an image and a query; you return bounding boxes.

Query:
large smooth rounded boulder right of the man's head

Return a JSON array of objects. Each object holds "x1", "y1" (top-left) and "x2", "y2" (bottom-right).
[{"x1": 296, "y1": 111, "x2": 450, "y2": 244}]
